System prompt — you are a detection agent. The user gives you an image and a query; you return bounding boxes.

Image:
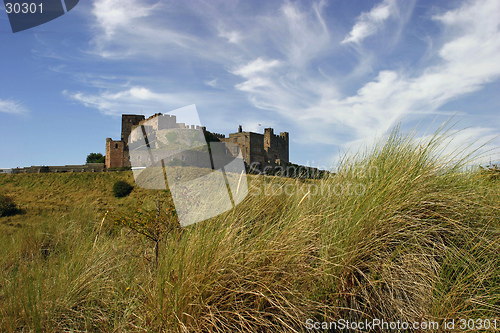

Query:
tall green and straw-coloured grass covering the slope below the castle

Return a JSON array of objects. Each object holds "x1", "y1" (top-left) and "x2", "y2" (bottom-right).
[{"x1": 0, "y1": 126, "x2": 500, "y2": 332}]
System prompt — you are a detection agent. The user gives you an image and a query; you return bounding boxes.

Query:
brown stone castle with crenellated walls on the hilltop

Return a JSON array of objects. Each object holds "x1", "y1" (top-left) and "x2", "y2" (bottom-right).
[{"x1": 105, "y1": 113, "x2": 289, "y2": 170}]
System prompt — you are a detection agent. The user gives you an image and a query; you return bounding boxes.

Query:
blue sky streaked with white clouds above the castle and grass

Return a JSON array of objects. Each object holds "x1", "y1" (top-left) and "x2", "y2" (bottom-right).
[{"x1": 0, "y1": 0, "x2": 500, "y2": 167}]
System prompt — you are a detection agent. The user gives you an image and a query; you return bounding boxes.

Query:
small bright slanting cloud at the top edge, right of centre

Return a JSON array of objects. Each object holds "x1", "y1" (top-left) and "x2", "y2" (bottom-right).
[{"x1": 342, "y1": 0, "x2": 397, "y2": 44}]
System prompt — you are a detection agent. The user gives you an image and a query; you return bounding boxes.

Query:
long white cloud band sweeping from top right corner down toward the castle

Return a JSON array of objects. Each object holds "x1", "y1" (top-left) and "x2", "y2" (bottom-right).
[{"x1": 233, "y1": 0, "x2": 500, "y2": 145}]
